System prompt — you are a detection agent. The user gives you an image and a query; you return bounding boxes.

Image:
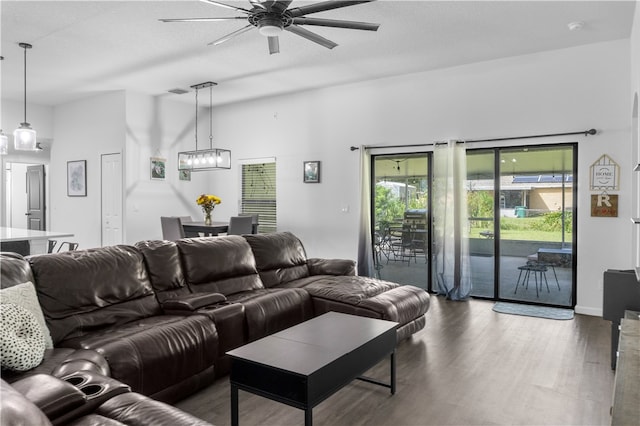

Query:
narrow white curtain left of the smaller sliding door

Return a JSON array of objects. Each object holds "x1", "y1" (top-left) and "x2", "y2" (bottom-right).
[{"x1": 358, "y1": 146, "x2": 373, "y2": 277}]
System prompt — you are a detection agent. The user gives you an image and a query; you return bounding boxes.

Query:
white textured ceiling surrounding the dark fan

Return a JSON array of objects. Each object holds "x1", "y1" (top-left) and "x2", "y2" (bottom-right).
[{"x1": 0, "y1": 0, "x2": 635, "y2": 105}]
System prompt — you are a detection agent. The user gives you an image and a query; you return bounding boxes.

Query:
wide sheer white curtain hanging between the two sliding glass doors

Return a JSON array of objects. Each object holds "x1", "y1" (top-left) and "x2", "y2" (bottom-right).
[{"x1": 433, "y1": 141, "x2": 471, "y2": 300}]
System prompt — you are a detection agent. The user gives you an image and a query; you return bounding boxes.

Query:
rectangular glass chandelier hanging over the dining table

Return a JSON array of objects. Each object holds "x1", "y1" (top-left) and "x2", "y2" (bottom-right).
[{"x1": 178, "y1": 81, "x2": 231, "y2": 172}]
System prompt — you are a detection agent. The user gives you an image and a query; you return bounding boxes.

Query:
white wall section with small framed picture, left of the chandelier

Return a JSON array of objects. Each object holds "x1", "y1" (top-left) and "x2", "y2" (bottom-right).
[{"x1": 125, "y1": 93, "x2": 215, "y2": 243}]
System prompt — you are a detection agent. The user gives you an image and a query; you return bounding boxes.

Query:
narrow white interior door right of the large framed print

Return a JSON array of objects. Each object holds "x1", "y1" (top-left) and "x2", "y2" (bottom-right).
[{"x1": 101, "y1": 153, "x2": 123, "y2": 246}]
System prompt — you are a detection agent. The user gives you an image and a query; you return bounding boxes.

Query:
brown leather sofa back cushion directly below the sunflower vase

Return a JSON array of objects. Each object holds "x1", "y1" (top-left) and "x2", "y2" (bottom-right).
[{"x1": 176, "y1": 235, "x2": 264, "y2": 296}]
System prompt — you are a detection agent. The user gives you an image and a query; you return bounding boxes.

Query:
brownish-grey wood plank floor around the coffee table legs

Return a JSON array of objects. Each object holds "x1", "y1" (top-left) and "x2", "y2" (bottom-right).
[{"x1": 177, "y1": 297, "x2": 614, "y2": 426}]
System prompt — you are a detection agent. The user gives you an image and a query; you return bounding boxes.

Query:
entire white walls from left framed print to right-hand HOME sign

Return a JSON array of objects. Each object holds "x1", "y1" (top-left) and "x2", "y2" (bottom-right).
[{"x1": 3, "y1": 36, "x2": 638, "y2": 315}]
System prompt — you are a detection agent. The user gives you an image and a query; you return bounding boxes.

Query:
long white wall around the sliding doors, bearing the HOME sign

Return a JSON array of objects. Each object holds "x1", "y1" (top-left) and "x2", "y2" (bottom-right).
[{"x1": 213, "y1": 40, "x2": 631, "y2": 314}]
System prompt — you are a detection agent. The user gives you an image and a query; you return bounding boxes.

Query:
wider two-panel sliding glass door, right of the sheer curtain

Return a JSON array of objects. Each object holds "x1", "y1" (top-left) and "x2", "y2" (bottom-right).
[{"x1": 467, "y1": 145, "x2": 576, "y2": 306}]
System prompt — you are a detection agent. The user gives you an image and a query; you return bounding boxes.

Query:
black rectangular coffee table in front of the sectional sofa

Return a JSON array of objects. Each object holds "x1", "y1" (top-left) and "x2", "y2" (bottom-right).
[{"x1": 227, "y1": 312, "x2": 398, "y2": 426}]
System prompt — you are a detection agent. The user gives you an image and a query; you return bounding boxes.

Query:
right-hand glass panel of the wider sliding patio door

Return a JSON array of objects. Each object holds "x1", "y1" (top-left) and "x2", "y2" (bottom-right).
[{"x1": 499, "y1": 145, "x2": 576, "y2": 306}]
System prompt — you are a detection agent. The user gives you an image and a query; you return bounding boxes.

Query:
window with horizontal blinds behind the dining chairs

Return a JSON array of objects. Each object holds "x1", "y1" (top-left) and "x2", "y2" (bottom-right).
[{"x1": 240, "y1": 159, "x2": 278, "y2": 233}]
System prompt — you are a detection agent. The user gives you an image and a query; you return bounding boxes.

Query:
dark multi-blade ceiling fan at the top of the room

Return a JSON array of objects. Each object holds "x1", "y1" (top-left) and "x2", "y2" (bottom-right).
[{"x1": 160, "y1": 0, "x2": 380, "y2": 54}]
